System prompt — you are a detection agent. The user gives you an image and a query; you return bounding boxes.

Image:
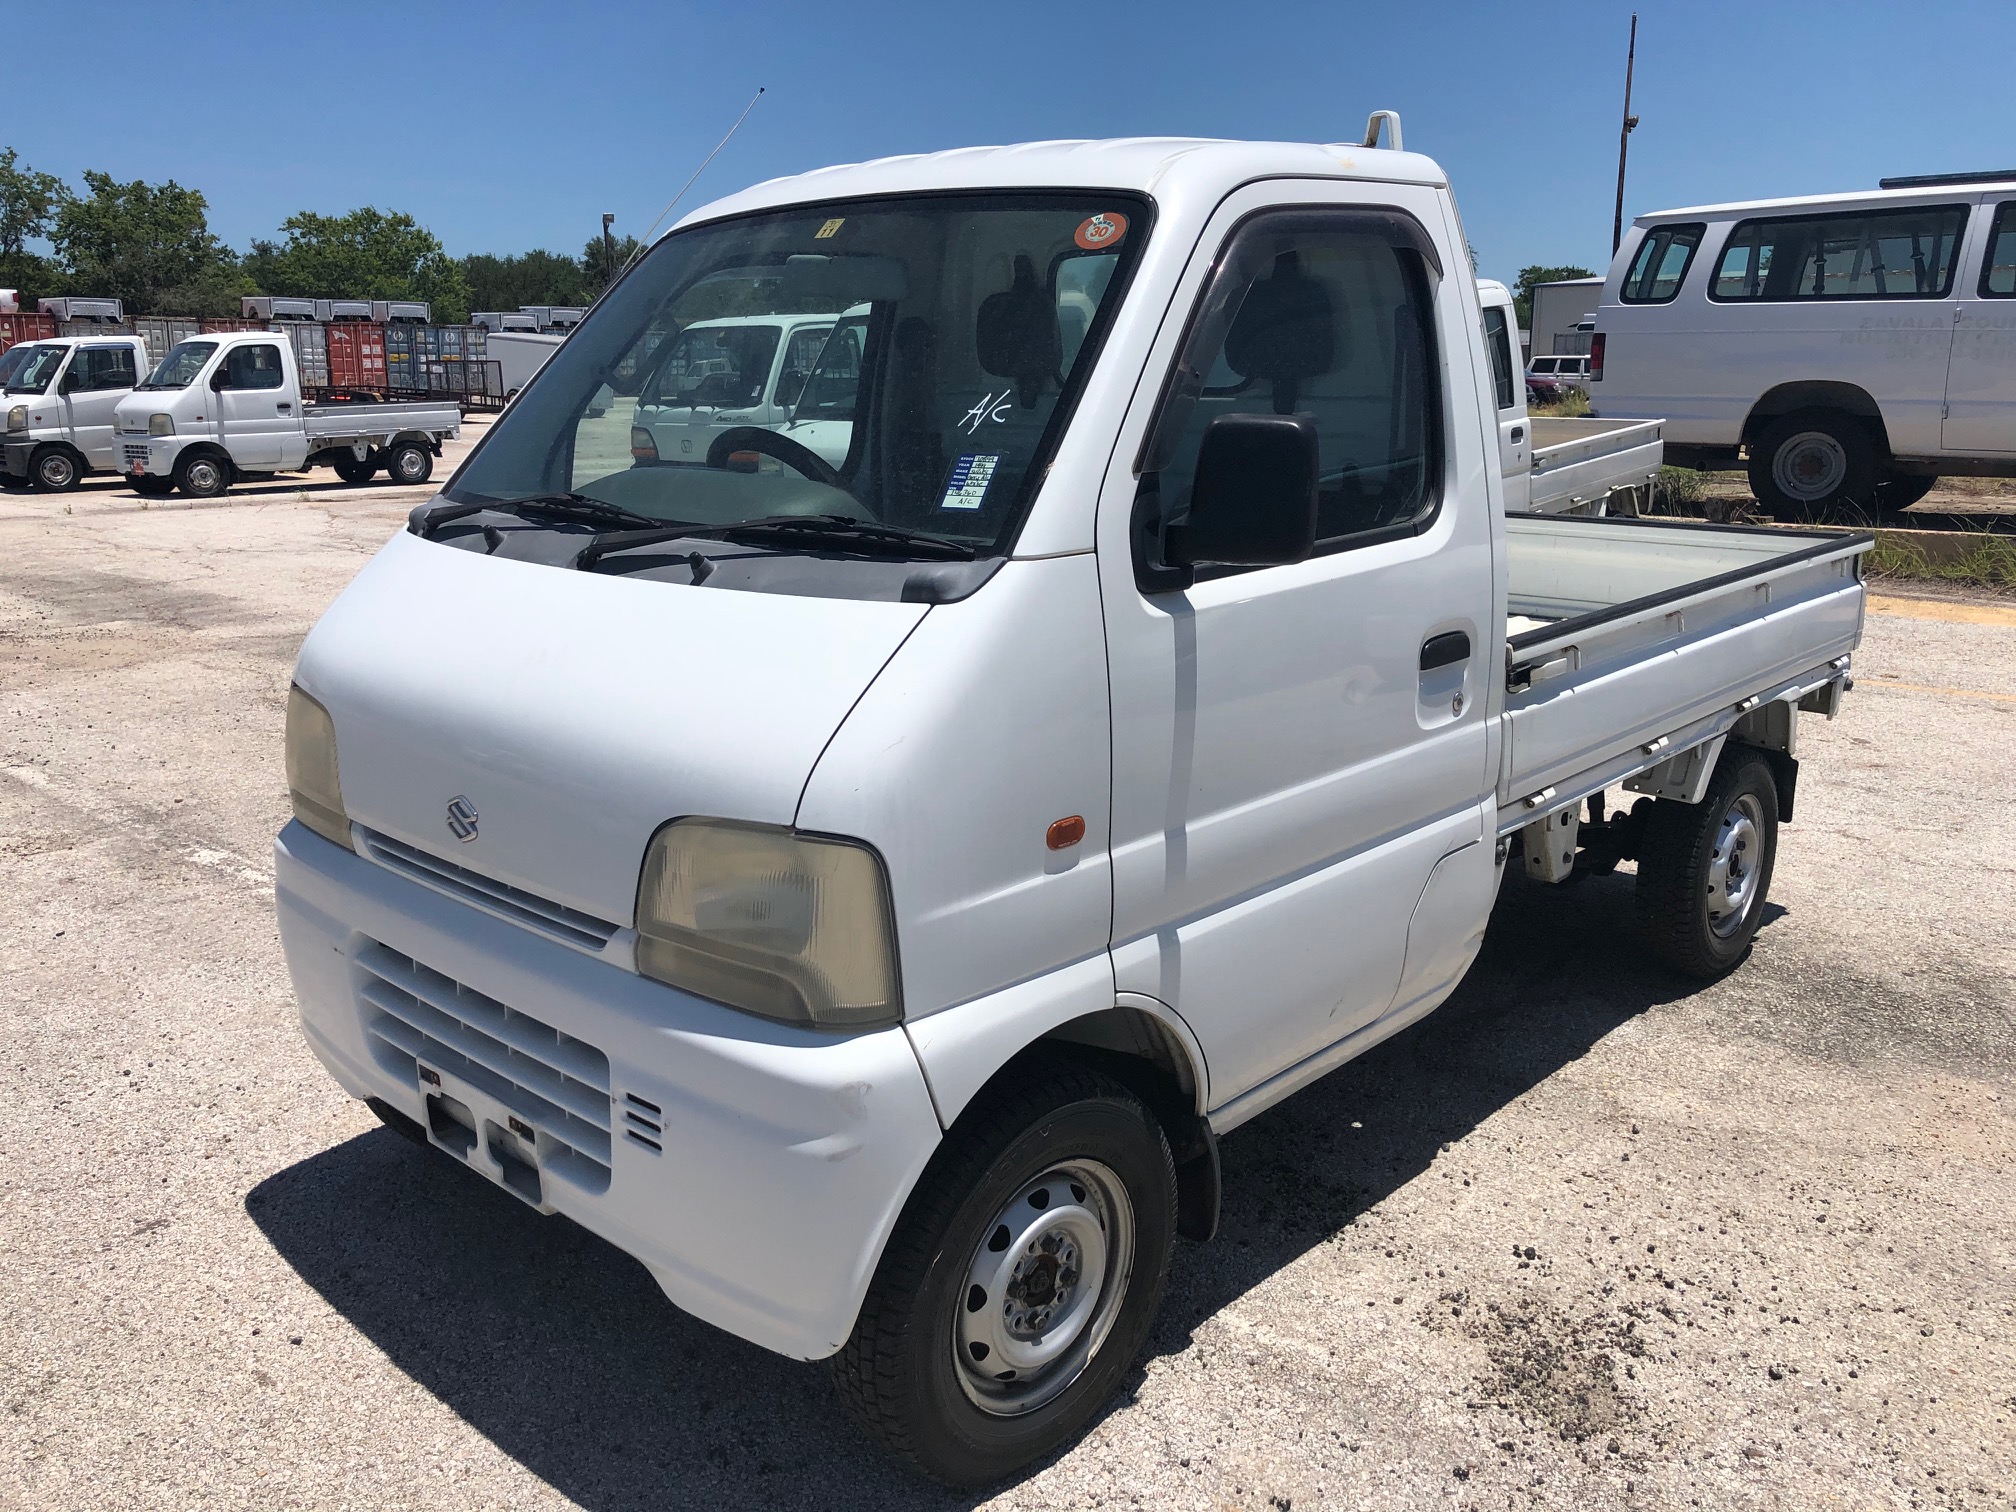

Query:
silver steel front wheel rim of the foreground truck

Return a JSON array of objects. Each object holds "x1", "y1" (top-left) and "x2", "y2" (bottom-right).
[{"x1": 952, "y1": 1159, "x2": 1135, "y2": 1417}]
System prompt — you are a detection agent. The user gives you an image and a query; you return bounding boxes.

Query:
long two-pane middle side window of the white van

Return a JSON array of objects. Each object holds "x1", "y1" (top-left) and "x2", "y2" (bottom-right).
[{"x1": 1710, "y1": 206, "x2": 1968, "y2": 300}]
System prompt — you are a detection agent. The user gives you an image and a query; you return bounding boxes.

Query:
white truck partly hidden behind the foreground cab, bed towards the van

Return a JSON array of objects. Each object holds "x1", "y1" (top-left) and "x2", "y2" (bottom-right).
[{"x1": 1478, "y1": 278, "x2": 1665, "y2": 514}]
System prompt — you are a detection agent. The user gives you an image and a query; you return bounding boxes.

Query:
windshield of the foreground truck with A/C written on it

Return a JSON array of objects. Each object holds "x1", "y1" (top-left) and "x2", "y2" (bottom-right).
[{"x1": 446, "y1": 192, "x2": 1149, "y2": 554}]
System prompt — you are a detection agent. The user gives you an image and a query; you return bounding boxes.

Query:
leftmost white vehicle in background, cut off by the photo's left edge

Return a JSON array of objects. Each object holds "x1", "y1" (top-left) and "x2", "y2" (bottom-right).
[{"x1": 0, "y1": 337, "x2": 147, "y2": 494}]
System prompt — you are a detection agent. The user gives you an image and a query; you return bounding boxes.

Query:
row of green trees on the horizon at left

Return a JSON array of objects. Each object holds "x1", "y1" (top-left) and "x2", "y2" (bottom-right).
[{"x1": 0, "y1": 147, "x2": 637, "y2": 323}]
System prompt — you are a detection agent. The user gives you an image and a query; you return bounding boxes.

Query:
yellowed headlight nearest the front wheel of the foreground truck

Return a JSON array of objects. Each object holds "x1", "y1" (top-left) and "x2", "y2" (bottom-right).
[{"x1": 633, "y1": 822, "x2": 903, "y2": 1028}]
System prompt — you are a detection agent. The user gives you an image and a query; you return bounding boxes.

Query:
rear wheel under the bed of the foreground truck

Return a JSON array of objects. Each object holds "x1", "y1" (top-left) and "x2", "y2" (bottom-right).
[{"x1": 1637, "y1": 746, "x2": 1778, "y2": 980}]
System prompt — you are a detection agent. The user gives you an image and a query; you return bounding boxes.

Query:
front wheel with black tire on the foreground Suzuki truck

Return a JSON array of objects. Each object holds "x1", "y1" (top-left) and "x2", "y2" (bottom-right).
[{"x1": 833, "y1": 1060, "x2": 1175, "y2": 1486}]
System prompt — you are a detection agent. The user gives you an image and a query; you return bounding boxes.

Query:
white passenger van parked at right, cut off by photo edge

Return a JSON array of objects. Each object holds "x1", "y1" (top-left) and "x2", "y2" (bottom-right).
[{"x1": 1589, "y1": 173, "x2": 2016, "y2": 512}]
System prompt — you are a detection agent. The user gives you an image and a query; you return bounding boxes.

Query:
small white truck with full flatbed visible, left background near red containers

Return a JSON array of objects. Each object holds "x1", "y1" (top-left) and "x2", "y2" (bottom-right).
[{"x1": 113, "y1": 331, "x2": 462, "y2": 498}]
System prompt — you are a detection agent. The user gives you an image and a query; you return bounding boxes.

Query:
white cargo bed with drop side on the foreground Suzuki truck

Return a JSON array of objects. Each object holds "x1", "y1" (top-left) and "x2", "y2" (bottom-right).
[{"x1": 1498, "y1": 514, "x2": 1875, "y2": 835}]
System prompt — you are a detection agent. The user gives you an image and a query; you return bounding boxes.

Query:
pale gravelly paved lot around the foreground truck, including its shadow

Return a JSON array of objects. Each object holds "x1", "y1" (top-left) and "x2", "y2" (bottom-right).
[{"x1": 0, "y1": 486, "x2": 2016, "y2": 1512}]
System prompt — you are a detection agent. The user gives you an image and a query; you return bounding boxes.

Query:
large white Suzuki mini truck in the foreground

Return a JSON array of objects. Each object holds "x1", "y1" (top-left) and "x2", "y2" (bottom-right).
[{"x1": 276, "y1": 121, "x2": 1869, "y2": 1484}]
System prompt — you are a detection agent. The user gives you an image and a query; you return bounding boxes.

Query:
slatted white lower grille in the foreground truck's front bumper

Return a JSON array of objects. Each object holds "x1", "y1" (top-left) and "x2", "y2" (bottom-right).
[{"x1": 357, "y1": 939, "x2": 611, "y2": 1191}]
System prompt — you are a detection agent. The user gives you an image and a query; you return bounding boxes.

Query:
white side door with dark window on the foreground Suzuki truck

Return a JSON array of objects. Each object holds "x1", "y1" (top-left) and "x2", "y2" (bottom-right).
[{"x1": 1099, "y1": 183, "x2": 1502, "y2": 1105}]
